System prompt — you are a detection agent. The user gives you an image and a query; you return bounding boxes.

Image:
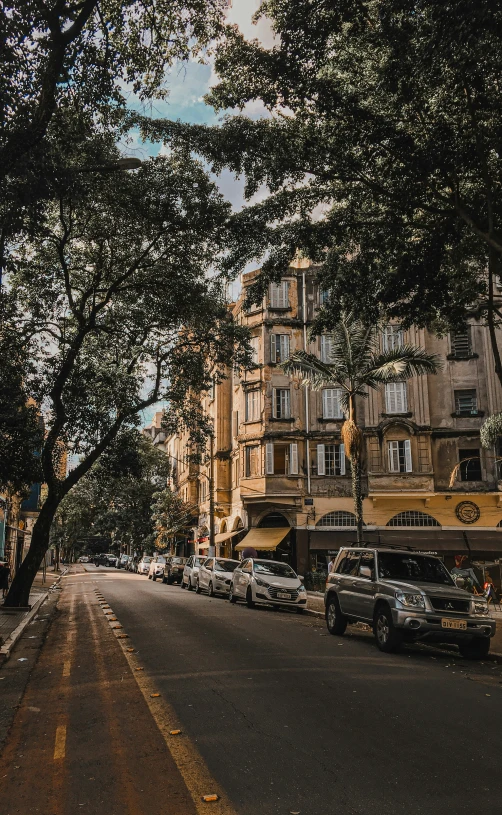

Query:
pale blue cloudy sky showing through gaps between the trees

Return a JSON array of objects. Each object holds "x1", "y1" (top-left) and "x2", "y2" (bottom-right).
[{"x1": 133, "y1": 0, "x2": 274, "y2": 427}]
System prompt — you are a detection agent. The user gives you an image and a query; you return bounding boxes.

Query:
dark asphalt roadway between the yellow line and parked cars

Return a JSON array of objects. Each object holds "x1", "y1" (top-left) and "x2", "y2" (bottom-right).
[{"x1": 93, "y1": 572, "x2": 502, "y2": 815}]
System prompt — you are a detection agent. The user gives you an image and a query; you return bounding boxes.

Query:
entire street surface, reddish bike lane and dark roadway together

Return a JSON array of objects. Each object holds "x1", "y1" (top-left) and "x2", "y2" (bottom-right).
[{"x1": 0, "y1": 565, "x2": 502, "y2": 815}]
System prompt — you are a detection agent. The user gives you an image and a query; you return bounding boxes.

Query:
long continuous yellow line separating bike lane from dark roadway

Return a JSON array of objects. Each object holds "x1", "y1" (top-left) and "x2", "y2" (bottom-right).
[{"x1": 120, "y1": 643, "x2": 237, "y2": 815}]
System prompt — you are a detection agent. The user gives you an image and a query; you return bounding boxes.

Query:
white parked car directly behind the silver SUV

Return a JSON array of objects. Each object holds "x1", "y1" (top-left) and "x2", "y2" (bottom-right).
[{"x1": 228, "y1": 558, "x2": 307, "y2": 612}]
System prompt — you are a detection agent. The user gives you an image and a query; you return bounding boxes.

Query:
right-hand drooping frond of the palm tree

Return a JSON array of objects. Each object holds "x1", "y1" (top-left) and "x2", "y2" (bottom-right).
[{"x1": 365, "y1": 345, "x2": 442, "y2": 387}]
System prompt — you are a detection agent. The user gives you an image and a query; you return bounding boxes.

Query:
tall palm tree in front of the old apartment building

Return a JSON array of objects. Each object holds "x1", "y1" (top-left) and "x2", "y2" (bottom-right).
[{"x1": 282, "y1": 312, "x2": 441, "y2": 543}]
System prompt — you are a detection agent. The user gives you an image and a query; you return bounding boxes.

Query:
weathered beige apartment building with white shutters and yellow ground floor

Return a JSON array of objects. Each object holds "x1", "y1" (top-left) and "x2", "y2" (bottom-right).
[{"x1": 163, "y1": 260, "x2": 502, "y2": 578}]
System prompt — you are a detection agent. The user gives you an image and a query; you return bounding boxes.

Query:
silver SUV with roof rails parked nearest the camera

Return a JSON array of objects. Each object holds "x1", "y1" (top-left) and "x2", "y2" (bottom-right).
[{"x1": 324, "y1": 547, "x2": 495, "y2": 659}]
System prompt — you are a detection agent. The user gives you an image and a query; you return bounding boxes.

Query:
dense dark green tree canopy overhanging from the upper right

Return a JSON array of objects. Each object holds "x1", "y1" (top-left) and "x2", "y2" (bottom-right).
[{"x1": 140, "y1": 0, "x2": 502, "y2": 378}]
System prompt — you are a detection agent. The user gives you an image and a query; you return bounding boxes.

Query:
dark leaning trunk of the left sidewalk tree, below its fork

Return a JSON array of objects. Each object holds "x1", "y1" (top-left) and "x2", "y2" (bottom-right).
[{"x1": 4, "y1": 495, "x2": 60, "y2": 608}]
